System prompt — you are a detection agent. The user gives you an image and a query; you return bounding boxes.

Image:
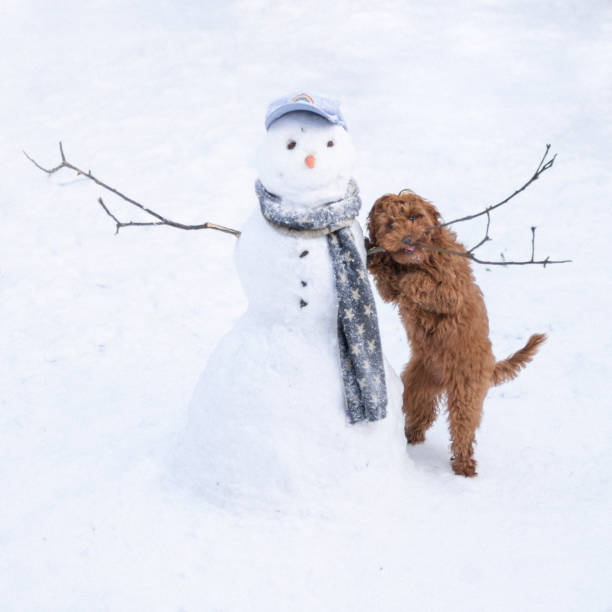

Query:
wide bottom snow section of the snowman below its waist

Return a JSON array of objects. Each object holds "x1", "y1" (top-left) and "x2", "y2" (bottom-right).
[{"x1": 174, "y1": 316, "x2": 410, "y2": 509}]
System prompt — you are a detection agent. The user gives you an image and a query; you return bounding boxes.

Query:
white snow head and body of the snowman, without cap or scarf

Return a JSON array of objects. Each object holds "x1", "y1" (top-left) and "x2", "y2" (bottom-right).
[{"x1": 181, "y1": 113, "x2": 403, "y2": 504}]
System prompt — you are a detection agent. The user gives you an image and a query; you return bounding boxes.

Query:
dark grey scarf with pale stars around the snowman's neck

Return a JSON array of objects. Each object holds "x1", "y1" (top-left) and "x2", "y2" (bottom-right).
[{"x1": 255, "y1": 181, "x2": 387, "y2": 423}]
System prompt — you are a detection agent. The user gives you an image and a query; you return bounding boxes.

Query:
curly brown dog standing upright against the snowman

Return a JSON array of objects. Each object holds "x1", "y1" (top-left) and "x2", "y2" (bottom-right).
[{"x1": 368, "y1": 192, "x2": 546, "y2": 476}]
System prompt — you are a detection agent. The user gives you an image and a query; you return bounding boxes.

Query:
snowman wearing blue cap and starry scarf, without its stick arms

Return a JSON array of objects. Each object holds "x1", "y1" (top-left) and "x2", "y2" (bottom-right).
[{"x1": 179, "y1": 94, "x2": 404, "y2": 505}]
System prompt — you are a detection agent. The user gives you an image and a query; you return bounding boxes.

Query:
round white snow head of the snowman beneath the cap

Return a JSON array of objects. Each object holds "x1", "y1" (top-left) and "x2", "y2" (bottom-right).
[{"x1": 257, "y1": 111, "x2": 354, "y2": 206}]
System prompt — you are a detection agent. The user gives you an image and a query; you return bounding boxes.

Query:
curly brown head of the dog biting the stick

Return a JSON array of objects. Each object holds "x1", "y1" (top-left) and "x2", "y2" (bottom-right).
[{"x1": 368, "y1": 191, "x2": 440, "y2": 264}]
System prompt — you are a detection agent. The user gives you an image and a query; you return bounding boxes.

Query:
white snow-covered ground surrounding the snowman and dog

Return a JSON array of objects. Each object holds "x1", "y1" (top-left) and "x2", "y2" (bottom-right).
[{"x1": 0, "y1": 0, "x2": 612, "y2": 612}]
